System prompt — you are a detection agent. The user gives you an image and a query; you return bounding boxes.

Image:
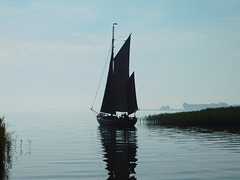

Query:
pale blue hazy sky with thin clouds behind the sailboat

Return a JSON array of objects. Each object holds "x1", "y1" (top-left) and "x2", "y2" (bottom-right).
[{"x1": 0, "y1": 0, "x2": 240, "y2": 110}]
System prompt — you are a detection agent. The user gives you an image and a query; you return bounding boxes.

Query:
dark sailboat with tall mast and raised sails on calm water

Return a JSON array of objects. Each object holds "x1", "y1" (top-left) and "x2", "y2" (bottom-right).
[{"x1": 92, "y1": 23, "x2": 138, "y2": 127}]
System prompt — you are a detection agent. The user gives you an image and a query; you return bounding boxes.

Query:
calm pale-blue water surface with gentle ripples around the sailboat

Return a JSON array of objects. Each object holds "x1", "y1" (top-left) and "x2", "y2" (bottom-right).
[{"x1": 0, "y1": 110, "x2": 240, "y2": 180}]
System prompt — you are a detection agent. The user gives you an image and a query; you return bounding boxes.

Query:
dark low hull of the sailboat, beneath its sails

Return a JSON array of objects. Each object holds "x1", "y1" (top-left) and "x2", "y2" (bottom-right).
[{"x1": 97, "y1": 116, "x2": 137, "y2": 127}]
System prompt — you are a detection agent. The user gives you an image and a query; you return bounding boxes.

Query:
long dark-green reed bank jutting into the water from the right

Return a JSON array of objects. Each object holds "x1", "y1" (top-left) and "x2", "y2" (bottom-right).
[{"x1": 144, "y1": 106, "x2": 240, "y2": 128}]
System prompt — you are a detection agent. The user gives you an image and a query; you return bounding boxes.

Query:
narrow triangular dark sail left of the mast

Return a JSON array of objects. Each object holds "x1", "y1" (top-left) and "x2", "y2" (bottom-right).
[{"x1": 101, "y1": 52, "x2": 116, "y2": 114}]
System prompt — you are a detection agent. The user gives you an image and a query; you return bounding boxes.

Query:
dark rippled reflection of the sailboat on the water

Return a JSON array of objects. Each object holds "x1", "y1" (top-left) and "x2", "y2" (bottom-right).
[{"x1": 99, "y1": 127, "x2": 137, "y2": 180}]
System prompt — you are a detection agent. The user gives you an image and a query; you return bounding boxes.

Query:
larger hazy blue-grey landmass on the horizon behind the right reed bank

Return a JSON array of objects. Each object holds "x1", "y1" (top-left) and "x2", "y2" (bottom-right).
[{"x1": 183, "y1": 102, "x2": 228, "y2": 110}]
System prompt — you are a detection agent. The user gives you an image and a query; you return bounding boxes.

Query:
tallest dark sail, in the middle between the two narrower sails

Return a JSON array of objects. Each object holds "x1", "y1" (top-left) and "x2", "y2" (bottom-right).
[{"x1": 114, "y1": 35, "x2": 131, "y2": 112}]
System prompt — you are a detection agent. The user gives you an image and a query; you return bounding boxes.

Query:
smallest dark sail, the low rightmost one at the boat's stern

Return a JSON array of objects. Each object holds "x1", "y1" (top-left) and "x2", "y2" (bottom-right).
[{"x1": 127, "y1": 72, "x2": 138, "y2": 114}]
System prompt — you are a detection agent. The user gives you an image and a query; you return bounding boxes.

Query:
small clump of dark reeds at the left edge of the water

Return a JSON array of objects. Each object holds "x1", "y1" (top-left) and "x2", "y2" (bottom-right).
[{"x1": 0, "y1": 117, "x2": 12, "y2": 179}]
